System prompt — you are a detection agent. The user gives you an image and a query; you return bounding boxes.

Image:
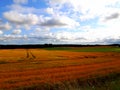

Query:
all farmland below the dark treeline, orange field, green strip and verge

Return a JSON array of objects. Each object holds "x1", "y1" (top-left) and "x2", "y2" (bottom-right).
[{"x1": 0, "y1": 46, "x2": 120, "y2": 90}]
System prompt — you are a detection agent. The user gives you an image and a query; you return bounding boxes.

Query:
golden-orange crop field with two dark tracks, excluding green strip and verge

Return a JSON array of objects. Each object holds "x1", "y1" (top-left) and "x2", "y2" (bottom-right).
[{"x1": 0, "y1": 49, "x2": 120, "y2": 90}]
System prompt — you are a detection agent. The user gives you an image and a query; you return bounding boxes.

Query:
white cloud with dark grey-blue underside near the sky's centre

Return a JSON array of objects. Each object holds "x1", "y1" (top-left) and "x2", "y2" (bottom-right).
[{"x1": 40, "y1": 16, "x2": 80, "y2": 28}]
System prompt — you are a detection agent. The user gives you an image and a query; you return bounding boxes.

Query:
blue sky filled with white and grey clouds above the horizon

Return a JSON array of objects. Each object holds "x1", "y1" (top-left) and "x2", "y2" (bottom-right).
[{"x1": 0, "y1": 0, "x2": 120, "y2": 44}]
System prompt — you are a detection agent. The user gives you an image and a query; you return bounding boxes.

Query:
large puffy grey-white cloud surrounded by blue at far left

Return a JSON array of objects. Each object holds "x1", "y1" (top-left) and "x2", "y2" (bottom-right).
[{"x1": 3, "y1": 11, "x2": 39, "y2": 30}]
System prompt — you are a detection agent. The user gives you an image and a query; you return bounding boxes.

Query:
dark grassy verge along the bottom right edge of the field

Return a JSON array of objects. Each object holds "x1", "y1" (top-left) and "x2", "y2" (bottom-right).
[{"x1": 15, "y1": 73, "x2": 120, "y2": 90}]
